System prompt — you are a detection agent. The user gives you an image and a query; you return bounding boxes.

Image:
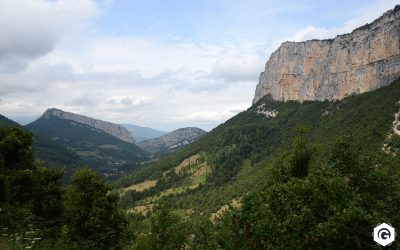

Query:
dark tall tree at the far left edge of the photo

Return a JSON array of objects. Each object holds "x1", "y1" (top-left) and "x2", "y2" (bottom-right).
[{"x1": 0, "y1": 127, "x2": 63, "y2": 249}]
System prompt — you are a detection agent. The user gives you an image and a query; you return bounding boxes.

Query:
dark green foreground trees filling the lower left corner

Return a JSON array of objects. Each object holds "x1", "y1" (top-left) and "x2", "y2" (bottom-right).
[{"x1": 0, "y1": 126, "x2": 127, "y2": 249}]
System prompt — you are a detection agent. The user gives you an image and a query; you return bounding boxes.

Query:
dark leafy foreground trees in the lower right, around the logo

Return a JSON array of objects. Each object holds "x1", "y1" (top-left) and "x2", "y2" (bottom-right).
[{"x1": 214, "y1": 136, "x2": 400, "y2": 249}]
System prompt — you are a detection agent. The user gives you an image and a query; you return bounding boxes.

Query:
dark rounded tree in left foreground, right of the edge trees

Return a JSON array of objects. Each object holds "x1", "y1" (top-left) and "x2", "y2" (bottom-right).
[{"x1": 64, "y1": 168, "x2": 127, "y2": 249}]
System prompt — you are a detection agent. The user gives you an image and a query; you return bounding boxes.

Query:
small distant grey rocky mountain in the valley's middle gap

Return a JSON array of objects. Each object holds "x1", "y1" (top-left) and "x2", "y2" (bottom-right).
[{"x1": 137, "y1": 127, "x2": 207, "y2": 158}]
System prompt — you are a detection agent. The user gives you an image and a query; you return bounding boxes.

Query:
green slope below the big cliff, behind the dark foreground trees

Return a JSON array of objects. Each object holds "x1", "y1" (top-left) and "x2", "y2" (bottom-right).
[{"x1": 114, "y1": 77, "x2": 400, "y2": 216}]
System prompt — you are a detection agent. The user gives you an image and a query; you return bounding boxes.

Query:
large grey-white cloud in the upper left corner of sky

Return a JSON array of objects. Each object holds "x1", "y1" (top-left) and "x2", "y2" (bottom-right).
[{"x1": 0, "y1": 0, "x2": 98, "y2": 73}]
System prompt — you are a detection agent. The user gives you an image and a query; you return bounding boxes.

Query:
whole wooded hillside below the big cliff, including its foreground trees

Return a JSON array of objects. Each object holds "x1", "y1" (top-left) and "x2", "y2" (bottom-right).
[{"x1": 114, "y1": 77, "x2": 400, "y2": 249}]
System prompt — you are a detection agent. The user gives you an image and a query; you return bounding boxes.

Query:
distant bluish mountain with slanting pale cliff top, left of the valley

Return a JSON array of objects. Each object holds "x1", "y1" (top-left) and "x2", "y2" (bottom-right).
[{"x1": 25, "y1": 109, "x2": 147, "y2": 176}]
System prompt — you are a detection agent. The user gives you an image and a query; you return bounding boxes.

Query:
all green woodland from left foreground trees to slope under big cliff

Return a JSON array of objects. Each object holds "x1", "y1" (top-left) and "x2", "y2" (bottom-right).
[{"x1": 0, "y1": 80, "x2": 400, "y2": 249}]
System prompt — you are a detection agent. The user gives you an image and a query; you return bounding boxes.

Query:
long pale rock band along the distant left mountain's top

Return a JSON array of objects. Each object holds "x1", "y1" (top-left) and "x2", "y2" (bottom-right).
[{"x1": 41, "y1": 108, "x2": 134, "y2": 143}]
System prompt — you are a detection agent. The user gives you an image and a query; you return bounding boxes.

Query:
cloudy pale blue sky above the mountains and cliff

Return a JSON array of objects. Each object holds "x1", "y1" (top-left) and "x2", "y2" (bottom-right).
[{"x1": 0, "y1": 0, "x2": 400, "y2": 131}]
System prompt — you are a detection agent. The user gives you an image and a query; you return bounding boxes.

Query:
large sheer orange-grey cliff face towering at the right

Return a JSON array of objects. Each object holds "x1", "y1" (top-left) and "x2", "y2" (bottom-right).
[{"x1": 253, "y1": 5, "x2": 400, "y2": 103}]
